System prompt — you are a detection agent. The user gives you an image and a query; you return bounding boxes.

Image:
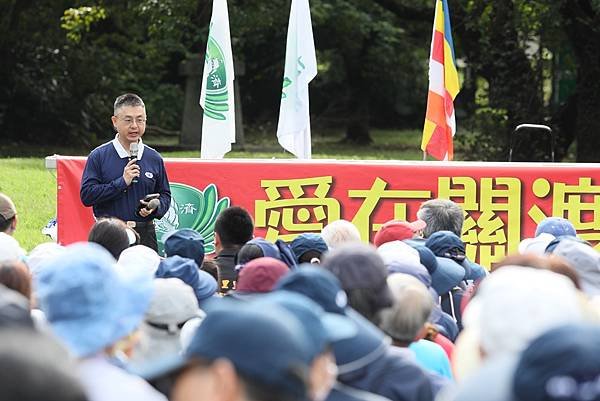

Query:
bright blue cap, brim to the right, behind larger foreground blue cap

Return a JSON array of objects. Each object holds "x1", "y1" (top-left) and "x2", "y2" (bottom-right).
[{"x1": 256, "y1": 291, "x2": 356, "y2": 362}]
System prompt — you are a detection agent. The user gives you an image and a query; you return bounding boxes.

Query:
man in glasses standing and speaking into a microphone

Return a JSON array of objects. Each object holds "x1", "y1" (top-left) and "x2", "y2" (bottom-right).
[{"x1": 79, "y1": 93, "x2": 171, "y2": 250}]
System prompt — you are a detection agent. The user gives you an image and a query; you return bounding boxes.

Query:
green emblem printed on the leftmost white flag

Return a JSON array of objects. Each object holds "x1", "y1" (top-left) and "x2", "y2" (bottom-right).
[{"x1": 204, "y1": 36, "x2": 229, "y2": 121}]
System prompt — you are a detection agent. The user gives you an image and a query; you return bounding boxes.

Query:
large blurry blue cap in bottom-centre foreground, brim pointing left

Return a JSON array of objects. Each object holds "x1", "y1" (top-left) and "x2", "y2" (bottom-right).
[{"x1": 185, "y1": 299, "x2": 309, "y2": 398}]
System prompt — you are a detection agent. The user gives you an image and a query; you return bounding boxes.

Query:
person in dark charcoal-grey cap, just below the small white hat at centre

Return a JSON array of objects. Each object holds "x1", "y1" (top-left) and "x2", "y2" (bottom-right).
[{"x1": 322, "y1": 243, "x2": 393, "y2": 324}]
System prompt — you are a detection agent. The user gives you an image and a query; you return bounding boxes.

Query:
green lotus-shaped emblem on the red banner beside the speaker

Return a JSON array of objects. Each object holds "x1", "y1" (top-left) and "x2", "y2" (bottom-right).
[{"x1": 156, "y1": 183, "x2": 231, "y2": 255}]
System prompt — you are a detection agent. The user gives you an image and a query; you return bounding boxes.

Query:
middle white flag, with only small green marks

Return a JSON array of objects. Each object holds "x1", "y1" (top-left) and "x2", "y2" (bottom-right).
[{"x1": 277, "y1": 0, "x2": 317, "y2": 159}]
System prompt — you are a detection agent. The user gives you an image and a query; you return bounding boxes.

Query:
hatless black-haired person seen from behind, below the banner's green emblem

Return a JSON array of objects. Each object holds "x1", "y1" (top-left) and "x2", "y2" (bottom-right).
[{"x1": 214, "y1": 206, "x2": 254, "y2": 294}]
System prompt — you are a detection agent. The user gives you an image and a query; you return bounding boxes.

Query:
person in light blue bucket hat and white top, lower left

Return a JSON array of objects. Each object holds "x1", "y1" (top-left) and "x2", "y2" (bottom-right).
[{"x1": 35, "y1": 243, "x2": 165, "y2": 401}]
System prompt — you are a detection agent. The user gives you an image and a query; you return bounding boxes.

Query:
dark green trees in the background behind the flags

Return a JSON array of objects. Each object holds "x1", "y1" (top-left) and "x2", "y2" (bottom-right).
[{"x1": 0, "y1": 0, "x2": 600, "y2": 160}]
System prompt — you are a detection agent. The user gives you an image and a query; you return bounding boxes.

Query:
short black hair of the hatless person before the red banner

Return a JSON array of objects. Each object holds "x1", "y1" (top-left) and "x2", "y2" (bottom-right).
[{"x1": 215, "y1": 206, "x2": 254, "y2": 247}]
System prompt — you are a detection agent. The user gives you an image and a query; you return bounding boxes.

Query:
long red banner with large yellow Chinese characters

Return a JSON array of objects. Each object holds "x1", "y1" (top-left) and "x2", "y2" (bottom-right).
[{"x1": 57, "y1": 157, "x2": 600, "y2": 266}]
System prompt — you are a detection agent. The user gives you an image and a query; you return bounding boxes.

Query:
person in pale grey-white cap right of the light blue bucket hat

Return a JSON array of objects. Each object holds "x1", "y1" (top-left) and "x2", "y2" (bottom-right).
[{"x1": 130, "y1": 278, "x2": 204, "y2": 366}]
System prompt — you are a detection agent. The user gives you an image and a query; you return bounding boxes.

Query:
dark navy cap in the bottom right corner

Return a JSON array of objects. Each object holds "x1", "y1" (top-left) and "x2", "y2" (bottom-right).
[{"x1": 513, "y1": 325, "x2": 600, "y2": 401}]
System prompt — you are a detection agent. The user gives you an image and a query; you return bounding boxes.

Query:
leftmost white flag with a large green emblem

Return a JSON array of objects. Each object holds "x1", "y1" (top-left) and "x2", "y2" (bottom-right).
[{"x1": 200, "y1": 0, "x2": 235, "y2": 159}]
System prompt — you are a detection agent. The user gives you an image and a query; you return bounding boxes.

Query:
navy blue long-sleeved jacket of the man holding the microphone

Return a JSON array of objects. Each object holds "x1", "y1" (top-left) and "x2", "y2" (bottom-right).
[{"x1": 79, "y1": 139, "x2": 171, "y2": 221}]
